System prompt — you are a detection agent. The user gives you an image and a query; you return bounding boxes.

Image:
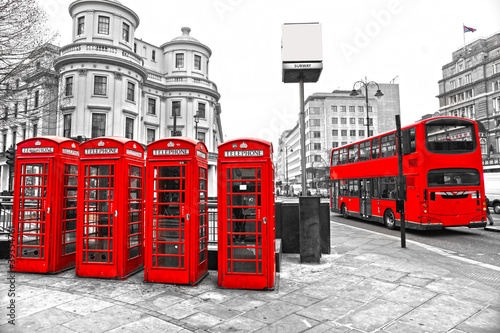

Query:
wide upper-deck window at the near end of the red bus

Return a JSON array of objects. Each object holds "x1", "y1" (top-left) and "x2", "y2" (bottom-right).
[{"x1": 425, "y1": 119, "x2": 477, "y2": 154}]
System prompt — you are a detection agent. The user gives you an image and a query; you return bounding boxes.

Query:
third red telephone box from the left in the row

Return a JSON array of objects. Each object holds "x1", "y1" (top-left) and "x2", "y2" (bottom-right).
[{"x1": 144, "y1": 137, "x2": 208, "y2": 285}]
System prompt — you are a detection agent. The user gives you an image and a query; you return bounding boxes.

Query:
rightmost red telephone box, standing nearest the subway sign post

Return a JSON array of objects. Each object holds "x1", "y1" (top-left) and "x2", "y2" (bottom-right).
[{"x1": 217, "y1": 138, "x2": 276, "y2": 289}]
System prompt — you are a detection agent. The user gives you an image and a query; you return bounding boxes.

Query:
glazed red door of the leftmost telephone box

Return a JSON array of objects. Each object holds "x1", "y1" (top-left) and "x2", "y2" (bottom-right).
[{"x1": 14, "y1": 159, "x2": 53, "y2": 272}]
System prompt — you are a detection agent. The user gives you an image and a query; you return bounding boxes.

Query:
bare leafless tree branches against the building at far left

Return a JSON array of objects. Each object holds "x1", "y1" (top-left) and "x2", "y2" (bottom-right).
[{"x1": 0, "y1": 0, "x2": 58, "y2": 130}]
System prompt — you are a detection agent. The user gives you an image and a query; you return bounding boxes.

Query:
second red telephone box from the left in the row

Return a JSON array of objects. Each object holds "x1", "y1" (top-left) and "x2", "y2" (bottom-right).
[{"x1": 76, "y1": 136, "x2": 144, "y2": 279}]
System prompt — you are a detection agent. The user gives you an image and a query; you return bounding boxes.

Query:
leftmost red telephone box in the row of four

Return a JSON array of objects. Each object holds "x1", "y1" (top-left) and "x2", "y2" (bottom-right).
[{"x1": 12, "y1": 136, "x2": 79, "y2": 273}]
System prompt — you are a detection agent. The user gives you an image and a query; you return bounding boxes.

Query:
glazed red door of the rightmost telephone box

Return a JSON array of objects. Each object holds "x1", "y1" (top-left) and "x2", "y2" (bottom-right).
[{"x1": 219, "y1": 163, "x2": 273, "y2": 289}]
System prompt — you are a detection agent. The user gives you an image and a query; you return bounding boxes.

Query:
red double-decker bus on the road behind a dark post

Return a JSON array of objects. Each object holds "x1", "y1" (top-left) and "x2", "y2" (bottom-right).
[{"x1": 330, "y1": 117, "x2": 487, "y2": 230}]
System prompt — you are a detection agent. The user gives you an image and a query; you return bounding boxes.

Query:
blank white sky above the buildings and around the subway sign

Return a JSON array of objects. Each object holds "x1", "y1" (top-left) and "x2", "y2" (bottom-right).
[{"x1": 40, "y1": 0, "x2": 500, "y2": 147}]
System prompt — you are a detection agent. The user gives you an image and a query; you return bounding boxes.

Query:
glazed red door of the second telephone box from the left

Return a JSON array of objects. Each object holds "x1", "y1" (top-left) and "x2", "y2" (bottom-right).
[{"x1": 77, "y1": 161, "x2": 119, "y2": 277}]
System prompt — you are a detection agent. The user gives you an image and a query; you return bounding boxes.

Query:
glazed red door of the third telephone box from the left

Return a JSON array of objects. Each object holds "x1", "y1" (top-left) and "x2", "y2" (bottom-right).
[{"x1": 148, "y1": 161, "x2": 190, "y2": 283}]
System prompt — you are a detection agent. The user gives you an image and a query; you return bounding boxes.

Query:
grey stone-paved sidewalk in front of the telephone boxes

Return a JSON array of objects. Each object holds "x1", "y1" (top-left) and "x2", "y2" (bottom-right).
[{"x1": 0, "y1": 222, "x2": 500, "y2": 333}]
